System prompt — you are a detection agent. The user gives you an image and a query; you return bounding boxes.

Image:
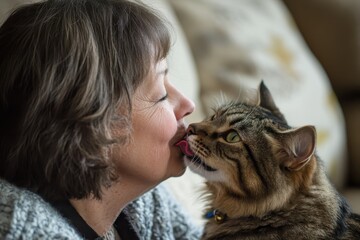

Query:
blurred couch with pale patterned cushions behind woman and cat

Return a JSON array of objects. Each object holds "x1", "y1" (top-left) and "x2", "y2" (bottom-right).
[{"x1": 0, "y1": 0, "x2": 360, "y2": 226}]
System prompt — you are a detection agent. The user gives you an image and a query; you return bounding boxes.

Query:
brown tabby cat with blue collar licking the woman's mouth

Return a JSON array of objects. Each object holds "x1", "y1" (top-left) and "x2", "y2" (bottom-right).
[{"x1": 181, "y1": 83, "x2": 360, "y2": 240}]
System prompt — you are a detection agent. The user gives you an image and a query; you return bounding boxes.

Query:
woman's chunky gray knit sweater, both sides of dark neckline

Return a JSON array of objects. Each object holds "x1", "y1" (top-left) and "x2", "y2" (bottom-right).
[{"x1": 0, "y1": 179, "x2": 201, "y2": 240}]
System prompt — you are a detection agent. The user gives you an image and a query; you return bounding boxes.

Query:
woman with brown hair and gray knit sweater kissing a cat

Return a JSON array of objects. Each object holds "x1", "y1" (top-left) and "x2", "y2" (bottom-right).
[{"x1": 0, "y1": 0, "x2": 200, "y2": 239}]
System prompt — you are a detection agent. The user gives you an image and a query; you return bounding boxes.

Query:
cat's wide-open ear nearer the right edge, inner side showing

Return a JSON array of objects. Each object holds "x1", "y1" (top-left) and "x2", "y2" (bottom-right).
[{"x1": 278, "y1": 126, "x2": 316, "y2": 171}]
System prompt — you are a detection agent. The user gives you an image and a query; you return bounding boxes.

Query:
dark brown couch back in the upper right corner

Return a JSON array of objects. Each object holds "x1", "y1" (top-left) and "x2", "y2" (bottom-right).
[{"x1": 283, "y1": 0, "x2": 360, "y2": 96}]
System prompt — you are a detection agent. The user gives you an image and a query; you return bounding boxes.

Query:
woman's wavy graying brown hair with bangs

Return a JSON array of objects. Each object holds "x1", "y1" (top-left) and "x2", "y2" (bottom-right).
[{"x1": 0, "y1": 0, "x2": 170, "y2": 200}]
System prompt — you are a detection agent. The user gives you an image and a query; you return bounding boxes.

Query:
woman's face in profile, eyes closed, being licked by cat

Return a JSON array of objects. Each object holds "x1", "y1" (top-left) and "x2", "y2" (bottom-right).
[{"x1": 112, "y1": 60, "x2": 194, "y2": 186}]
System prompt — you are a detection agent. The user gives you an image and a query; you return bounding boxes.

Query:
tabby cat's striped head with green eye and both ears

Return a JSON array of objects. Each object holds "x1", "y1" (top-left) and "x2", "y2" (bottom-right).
[{"x1": 186, "y1": 82, "x2": 316, "y2": 207}]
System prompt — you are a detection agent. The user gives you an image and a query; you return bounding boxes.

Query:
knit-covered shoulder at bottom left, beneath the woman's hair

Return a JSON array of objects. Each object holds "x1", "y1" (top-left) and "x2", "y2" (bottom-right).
[{"x1": 0, "y1": 179, "x2": 80, "y2": 239}]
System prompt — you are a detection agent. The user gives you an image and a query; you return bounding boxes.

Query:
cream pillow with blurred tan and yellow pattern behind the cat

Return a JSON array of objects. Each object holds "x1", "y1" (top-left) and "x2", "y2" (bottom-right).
[{"x1": 170, "y1": 0, "x2": 346, "y2": 187}]
